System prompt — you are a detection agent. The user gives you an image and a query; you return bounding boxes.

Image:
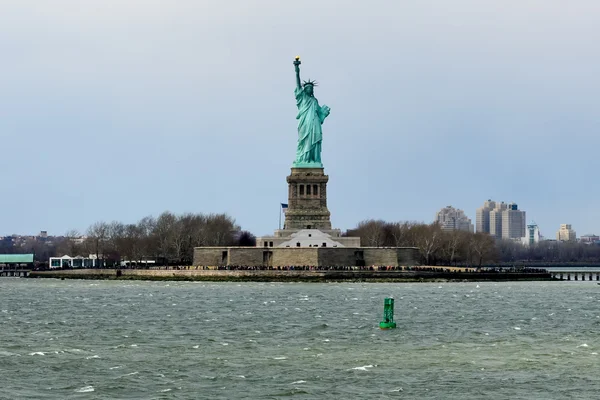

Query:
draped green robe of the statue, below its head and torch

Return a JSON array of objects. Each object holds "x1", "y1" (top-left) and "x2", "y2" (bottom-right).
[{"x1": 294, "y1": 87, "x2": 329, "y2": 164}]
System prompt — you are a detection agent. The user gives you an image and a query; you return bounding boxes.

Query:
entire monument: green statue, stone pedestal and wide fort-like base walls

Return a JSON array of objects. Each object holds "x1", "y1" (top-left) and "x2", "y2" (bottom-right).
[{"x1": 194, "y1": 57, "x2": 419, "y2": 268}]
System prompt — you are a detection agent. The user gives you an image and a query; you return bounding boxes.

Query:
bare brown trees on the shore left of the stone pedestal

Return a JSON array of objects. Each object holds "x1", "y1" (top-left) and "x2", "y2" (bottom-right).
[{"x1": 0, "y1": 212, "x2": 256, "y2": 265}]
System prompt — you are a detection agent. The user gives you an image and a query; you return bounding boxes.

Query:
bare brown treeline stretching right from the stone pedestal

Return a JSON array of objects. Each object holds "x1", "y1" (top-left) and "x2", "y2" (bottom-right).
[{"x1": 346, "y1": 219, "x2": 600, "y2": 266}]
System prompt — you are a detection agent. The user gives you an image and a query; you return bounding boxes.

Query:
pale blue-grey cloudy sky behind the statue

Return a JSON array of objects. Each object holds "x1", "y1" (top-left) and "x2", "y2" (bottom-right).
[{"x1": 0, "y1": 0, "x2": 600, "y2": 238}]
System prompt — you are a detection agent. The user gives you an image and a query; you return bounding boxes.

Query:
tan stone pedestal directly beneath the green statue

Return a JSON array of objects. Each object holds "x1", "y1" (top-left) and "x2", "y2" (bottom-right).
[{"x1": 284, "y1": 168, "x2": 331, "y2": 230}]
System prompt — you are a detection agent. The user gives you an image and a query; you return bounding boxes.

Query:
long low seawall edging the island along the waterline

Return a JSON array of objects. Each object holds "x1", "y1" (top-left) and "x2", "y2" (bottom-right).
[{"x1": 29, "y1": 269, "x2": 553, "y2": 282}]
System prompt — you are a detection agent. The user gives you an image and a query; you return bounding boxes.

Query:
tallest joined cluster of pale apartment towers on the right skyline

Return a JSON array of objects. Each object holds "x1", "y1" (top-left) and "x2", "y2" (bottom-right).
[{"x1": 476, "y1": 200, "x2": 525, "y2": 239}]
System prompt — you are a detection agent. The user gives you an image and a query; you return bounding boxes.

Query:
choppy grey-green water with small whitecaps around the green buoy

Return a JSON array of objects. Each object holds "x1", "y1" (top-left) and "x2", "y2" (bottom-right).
[{"x1": 0, "y1": 279, "x2": 600, "y2": 399}]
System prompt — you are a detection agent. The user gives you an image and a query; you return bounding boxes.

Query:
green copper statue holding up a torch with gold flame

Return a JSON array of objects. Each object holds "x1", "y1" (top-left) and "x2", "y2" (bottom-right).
[{"x1": 293, "y1": 57, "x2": 330, "y2": 168}]
